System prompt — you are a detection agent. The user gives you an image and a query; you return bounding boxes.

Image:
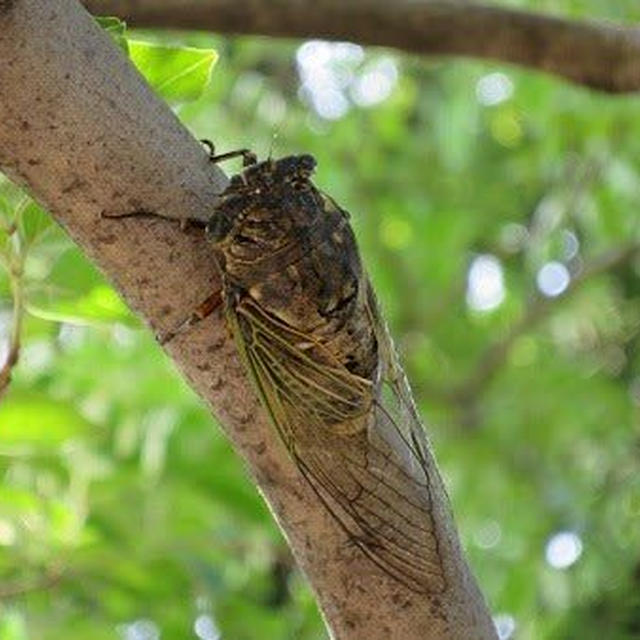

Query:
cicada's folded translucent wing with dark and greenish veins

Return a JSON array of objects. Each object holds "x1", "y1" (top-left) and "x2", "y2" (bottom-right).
[{"x1": 229, "y1": 292, "x2": 446, "y2": 593}]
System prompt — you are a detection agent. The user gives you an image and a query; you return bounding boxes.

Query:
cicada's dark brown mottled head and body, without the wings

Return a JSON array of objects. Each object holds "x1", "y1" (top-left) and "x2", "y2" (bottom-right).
[{"x1": 208, "y1": 156, "x2": 377, "y2": 388}]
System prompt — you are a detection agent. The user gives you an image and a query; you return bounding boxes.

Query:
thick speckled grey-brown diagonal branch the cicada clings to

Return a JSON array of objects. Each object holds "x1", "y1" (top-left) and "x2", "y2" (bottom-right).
[{"x1": 0, "y1": 0, "x2": 496, "y2": 640}]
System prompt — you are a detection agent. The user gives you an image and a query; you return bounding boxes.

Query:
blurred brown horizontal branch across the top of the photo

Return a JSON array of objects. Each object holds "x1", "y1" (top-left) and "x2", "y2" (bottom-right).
[{"x1": 84, "y1": 0, "x2": 640, "y2": 93}]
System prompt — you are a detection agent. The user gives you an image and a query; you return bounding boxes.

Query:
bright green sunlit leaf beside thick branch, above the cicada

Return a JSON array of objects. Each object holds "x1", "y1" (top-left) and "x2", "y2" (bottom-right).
[{"x1": 129, "y1": 40, "x2": 218, "y2": 104}]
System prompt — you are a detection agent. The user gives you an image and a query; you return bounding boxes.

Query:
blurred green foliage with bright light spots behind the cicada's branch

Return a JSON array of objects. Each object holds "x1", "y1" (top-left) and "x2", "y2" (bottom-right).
[{"x1": 0, "y1": 0, "x2": 640, "y2": 640}]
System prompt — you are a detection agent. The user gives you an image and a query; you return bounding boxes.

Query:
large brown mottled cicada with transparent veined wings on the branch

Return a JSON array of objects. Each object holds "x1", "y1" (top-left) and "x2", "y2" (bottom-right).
[{"x1": 207, "y1": 153, "x2": 446, "y2": 593}]
